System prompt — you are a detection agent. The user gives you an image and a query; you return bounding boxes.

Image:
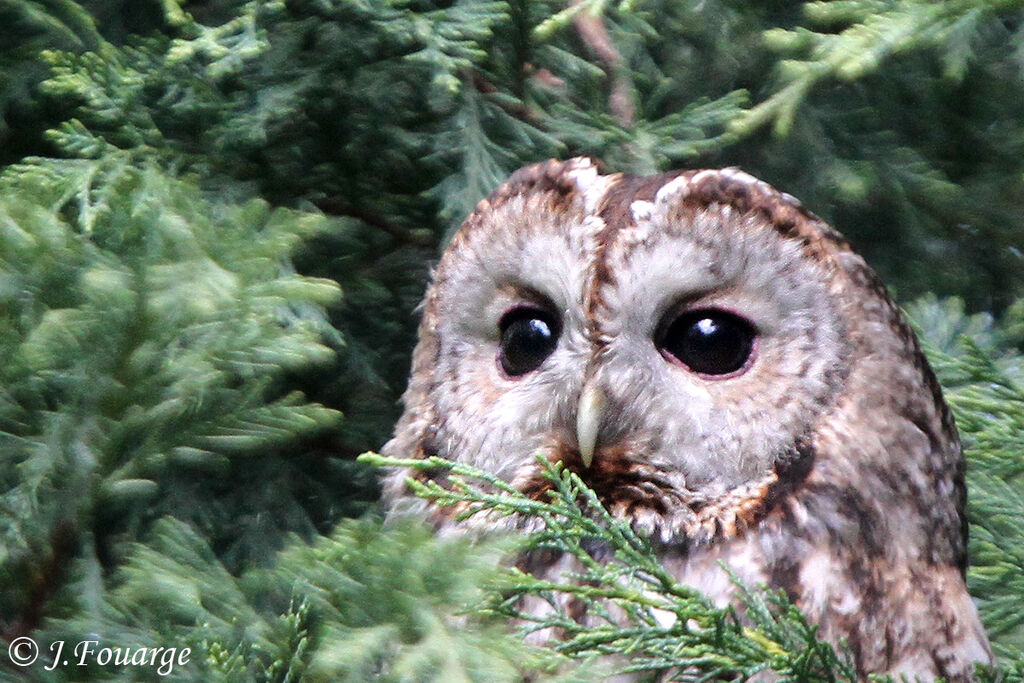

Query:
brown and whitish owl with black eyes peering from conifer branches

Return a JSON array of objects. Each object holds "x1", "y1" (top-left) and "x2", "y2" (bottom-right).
[{"x1": 383, "y1": 159, "x2": 991, "y2": 681}]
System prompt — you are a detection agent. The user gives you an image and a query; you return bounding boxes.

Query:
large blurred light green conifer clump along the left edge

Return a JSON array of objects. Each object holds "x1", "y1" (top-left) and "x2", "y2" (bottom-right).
[{"x1": 0, "y1": 156, "x2": 339, "y2": 632}]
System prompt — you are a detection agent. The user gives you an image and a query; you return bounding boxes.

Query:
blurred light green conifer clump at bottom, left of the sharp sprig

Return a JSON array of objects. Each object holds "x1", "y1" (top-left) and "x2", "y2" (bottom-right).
[{"x1": 34, "y1": 518, "x2": 594, "y2": 683}]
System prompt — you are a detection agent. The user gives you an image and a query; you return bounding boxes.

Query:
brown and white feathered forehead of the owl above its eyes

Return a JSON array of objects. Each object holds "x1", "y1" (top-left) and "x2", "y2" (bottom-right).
[{"x1": 437, "y1": 159, "x2": 848, "y2": 332}]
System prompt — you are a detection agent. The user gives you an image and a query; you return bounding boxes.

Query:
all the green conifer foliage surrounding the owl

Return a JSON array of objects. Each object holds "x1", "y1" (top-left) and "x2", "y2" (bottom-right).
[{"x1": 0, "y1": 0, "x2": 1024, "y2": 681}]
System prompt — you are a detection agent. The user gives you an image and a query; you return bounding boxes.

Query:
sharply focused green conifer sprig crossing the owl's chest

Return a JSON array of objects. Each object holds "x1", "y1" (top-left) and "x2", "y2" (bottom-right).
[{"x1": 361, "y1": 454, "x2": 856, "y2": 681}]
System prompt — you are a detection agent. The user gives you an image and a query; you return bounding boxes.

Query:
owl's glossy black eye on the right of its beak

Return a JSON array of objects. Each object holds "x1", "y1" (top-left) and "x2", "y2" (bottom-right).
[{"x1": 655, "y1": 309, "x2": 757, "y2": 375}]
